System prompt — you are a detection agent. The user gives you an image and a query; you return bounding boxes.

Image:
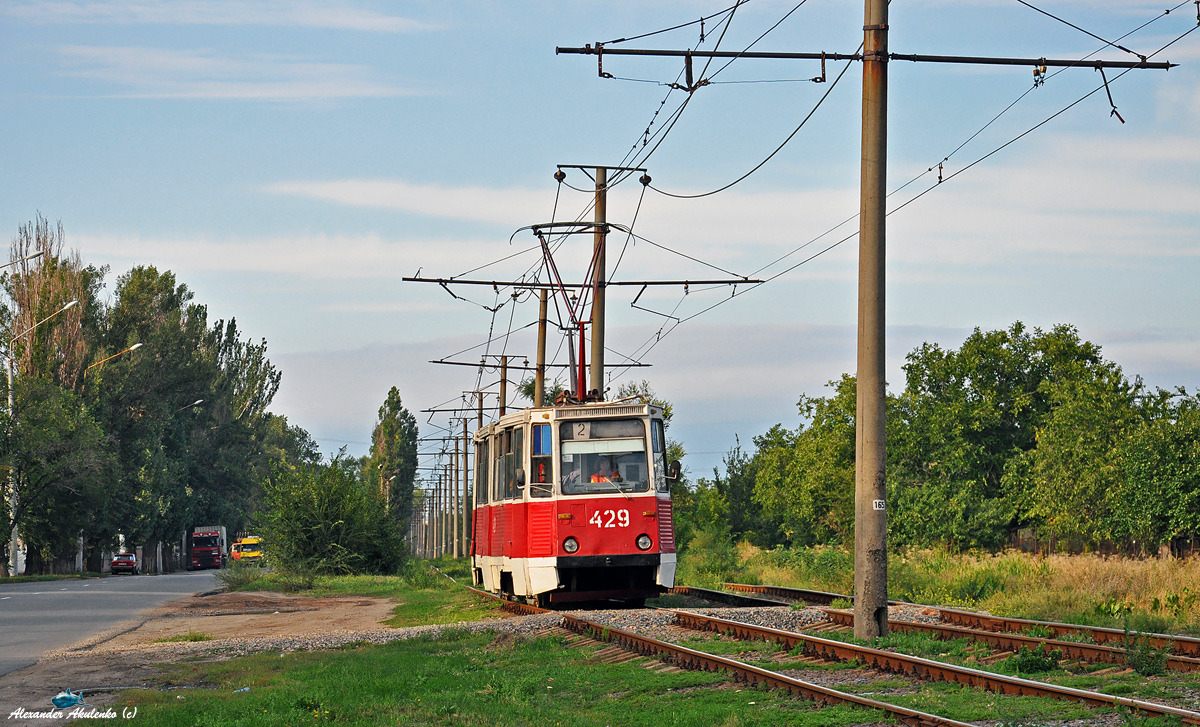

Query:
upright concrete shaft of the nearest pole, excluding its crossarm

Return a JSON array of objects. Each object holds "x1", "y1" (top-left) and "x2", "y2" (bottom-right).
[{"x1": 854, "y1": 0, "x2": 888, "y2": 638}]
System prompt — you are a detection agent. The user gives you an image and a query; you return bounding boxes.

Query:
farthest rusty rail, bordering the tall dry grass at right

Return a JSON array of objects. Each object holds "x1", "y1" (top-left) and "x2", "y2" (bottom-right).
[{"x1": 724, "y1": 583, "x2": 1200, "y2": 659}]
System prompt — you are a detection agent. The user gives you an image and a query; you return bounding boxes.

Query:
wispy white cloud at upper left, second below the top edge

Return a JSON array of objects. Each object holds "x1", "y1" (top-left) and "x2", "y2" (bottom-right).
[{"x1": 59, "y1": 46, "x2": 415, "y2": 101}]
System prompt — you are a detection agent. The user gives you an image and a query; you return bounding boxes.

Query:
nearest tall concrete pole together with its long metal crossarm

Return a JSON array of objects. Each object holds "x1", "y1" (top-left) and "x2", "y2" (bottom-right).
[{"x1": 557, "y1": 8, "x2": 1171, "y2": 638}]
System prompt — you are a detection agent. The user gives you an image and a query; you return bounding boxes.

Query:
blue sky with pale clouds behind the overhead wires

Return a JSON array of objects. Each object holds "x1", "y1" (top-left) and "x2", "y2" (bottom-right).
[{"x1": 0, "y1": 0, "x2": 1200, "y2": 474}]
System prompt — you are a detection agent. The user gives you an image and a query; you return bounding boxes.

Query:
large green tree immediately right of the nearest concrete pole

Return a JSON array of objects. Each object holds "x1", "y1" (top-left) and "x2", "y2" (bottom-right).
[{"x1": 888, "y1": 322, "x2": 1104, "y2": 548}]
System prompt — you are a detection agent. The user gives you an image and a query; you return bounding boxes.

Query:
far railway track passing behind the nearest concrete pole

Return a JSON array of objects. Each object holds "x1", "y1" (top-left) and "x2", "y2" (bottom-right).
[{"x1": 724, "y1": 583, "x2": 1200, "y2": 672}]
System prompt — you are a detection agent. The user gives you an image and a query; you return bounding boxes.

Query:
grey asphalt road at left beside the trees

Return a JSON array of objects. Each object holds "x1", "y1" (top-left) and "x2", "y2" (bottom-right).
[{"x1": 0, "y1": 571, "x2": 216, "y2": 675}]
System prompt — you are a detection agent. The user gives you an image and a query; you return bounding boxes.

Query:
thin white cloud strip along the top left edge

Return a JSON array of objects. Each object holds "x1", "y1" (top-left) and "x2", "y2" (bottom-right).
[{"x1": 0, "y1": 0, "x2": 433, "y2": 32}]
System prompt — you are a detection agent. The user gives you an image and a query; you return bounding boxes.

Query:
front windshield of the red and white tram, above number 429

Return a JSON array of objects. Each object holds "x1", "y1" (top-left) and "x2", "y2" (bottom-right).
[{"x1": 559, "y1": 419, "x2": 650, "y2": 494}]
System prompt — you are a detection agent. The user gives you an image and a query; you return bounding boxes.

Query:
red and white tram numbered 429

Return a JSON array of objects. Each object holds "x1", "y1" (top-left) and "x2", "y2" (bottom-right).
[{"x1": 472, "y1": 399, "x2": 678, "y2": 605}]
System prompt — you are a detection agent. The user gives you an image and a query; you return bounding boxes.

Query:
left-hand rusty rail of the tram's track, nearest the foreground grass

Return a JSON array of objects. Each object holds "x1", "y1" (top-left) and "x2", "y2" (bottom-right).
[{"x1": 464, "y1": 585, "x2": 972, "y2": 727}]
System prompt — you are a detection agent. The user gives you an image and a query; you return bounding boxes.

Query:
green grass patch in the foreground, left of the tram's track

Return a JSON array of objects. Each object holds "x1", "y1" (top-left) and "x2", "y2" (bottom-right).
[{"x1": 119, "y1": 631, "x2": 882, "y2": 727}]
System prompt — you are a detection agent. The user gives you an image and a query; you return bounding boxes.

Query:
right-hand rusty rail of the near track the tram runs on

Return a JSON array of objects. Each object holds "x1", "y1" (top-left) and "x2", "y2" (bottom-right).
[{"x1": 664, "y1": 609, "x2": 1200, "y2": 725}]
